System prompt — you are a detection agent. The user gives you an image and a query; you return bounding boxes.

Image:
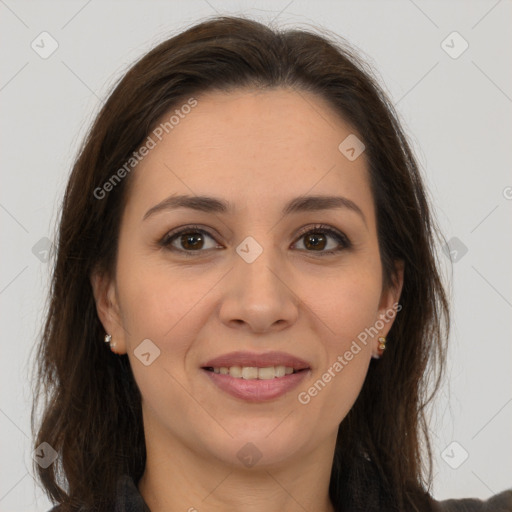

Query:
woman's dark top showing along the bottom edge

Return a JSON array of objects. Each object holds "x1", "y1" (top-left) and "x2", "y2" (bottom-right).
[{"x1": 49, "y1": 475, "x2": 512, "y2": 512}]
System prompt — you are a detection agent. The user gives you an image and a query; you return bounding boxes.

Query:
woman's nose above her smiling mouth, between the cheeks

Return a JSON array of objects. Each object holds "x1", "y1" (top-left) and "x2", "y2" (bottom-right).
[{"x1": 219, "y1": 242, "x2": 300, "y2": 333}]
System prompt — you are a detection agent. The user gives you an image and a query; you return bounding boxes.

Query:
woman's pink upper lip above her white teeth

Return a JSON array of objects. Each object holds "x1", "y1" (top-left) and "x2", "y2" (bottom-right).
[{"x1": 201, "y1": 351, "x2": 310, "y2": 370}]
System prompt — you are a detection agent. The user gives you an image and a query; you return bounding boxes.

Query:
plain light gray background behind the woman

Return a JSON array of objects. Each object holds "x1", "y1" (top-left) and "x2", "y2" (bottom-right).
[{"x1": 0, "y1": 0, "x2": 512, "y2": 511}]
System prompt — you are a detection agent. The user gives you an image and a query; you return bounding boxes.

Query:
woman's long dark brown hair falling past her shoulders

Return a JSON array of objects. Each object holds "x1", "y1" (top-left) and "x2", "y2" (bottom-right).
[{"x1": 32, "y1": 17, "x2": 449, "y2": 511}]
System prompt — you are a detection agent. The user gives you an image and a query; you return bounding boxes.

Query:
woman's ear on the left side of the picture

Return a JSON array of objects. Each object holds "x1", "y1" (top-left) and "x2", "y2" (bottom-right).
[{"x1": 90, "y1": 271, "x2": 126, "y2": 354}]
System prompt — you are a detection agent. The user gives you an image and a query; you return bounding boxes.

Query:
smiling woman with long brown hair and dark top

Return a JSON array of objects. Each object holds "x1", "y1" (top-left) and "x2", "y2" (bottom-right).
[{"x1": 35, "y1": 17, "x2": 512, "y2": 512}]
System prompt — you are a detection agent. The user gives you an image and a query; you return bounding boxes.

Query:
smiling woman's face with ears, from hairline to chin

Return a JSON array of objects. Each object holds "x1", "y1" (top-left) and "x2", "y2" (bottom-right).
[{"x1": 93, "y1": 89, "x2": 401, "y2": 466}]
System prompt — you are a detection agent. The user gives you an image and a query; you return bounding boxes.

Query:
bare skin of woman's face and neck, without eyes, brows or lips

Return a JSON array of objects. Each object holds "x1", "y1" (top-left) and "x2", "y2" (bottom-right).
[{"x1": 92, "y1": 89, "x2": 403, "y2": 512}]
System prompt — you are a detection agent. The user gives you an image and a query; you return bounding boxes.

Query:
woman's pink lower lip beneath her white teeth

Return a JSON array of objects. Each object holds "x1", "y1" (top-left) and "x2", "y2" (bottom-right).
[{"x1": 203, "y1": 369, "x2": 310, "y2": 402}]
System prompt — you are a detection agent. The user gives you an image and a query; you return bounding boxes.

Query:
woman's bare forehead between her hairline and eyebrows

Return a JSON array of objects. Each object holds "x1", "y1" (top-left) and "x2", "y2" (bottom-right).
[{"x1": 125, "y1": 89, "x2": 371, "y2": 218}]
